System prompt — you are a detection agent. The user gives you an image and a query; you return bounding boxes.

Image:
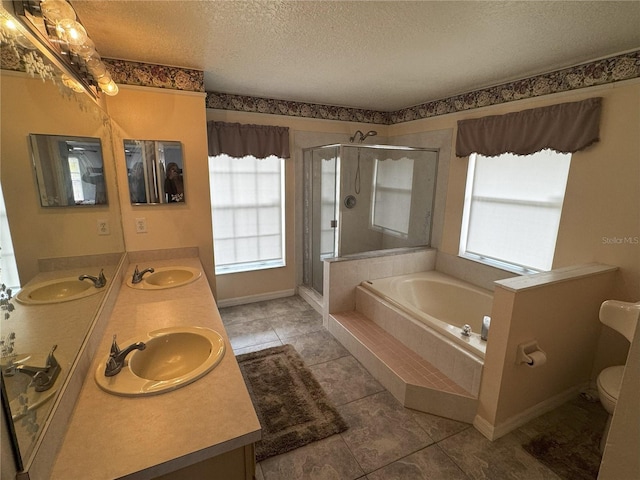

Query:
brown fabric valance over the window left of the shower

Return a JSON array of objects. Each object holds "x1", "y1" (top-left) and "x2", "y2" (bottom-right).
[{"x1": 207, "y1": 121, "x2": 290, "y2": 158}]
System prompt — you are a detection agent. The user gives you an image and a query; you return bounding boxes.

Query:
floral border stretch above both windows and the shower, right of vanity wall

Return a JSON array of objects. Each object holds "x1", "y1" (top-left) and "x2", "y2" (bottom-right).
[{"x1": 206, "y1": 50, "x2": 640, "y2": 125}]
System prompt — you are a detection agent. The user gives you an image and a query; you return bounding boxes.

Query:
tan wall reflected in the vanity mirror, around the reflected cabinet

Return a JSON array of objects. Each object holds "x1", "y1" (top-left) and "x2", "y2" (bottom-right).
[{"x1": 0, "y1": 70, "x2": 124, "y2": 284}]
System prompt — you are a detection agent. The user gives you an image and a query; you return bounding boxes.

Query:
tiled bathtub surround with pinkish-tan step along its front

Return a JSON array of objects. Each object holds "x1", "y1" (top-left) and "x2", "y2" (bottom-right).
[{"x1": 325, "y1": 248, "x2": 483, "y2": 422}]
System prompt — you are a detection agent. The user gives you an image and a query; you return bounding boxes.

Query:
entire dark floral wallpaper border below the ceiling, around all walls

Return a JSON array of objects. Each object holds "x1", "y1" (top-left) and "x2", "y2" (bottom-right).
[{"x1": 1, "y1": 48, "x2": 640, "y2": 121}]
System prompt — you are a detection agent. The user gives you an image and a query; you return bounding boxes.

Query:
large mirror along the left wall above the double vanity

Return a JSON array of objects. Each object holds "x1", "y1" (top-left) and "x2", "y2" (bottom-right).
[{"x1": 0, "y1": 42, "x2": 124, "y2": 474}]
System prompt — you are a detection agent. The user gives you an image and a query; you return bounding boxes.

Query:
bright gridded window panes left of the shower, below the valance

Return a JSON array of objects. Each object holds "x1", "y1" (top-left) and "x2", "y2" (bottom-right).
[{"x1": 209, "y1": 155, "x2": 285, "y2": 274}]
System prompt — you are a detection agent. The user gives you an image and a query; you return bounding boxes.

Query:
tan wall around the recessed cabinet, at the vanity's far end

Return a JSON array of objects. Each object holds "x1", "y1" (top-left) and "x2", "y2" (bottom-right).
[{"x1": 107, "y1": 87, "x2": 216, "y2": 293}]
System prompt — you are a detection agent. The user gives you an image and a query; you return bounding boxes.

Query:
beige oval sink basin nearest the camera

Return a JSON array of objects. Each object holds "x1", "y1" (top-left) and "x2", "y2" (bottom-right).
[{"x1": 95, "y1": 327, "x2": 225, "y2": 397}]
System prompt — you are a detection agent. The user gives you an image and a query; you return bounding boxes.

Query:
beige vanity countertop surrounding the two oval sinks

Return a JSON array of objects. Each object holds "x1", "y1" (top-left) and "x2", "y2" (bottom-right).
[{"x1": 51, "y1": 258, "x2": 260, "y2": 480}]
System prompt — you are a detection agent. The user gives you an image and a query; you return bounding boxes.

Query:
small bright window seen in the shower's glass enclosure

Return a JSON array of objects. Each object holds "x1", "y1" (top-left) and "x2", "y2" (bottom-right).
[{"x1": 371, "y1": 157, "x2": 413, "y2": 238}]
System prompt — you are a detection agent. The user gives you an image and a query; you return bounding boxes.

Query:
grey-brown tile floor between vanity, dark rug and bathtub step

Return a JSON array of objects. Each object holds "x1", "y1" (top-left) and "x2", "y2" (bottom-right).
[{"x1": 220, "y1": 296, "x2": 604, "y2": 480}]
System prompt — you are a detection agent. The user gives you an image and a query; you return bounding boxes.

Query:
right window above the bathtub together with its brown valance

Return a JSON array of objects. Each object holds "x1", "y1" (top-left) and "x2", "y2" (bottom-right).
[{"x1": 456, "y1": 98, "x2": 602, "y2": 273}]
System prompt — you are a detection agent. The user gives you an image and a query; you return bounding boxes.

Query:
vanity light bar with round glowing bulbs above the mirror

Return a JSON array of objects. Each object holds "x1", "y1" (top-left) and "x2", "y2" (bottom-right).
[{"x1": 5, "y1": 0, "x2": 118, "y2": 98}]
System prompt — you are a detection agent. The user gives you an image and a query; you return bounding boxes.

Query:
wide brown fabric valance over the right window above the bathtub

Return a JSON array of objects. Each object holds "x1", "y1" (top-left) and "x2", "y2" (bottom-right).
[{"x1": 456, "y1": 97, "x2": 602, "y2": 157}]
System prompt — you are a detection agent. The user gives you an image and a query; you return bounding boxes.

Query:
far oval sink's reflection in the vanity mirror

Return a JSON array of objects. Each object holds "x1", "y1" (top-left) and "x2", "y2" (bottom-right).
[{"x1": 16, "y1": 277, "x2": 104, "y2": 305}]
